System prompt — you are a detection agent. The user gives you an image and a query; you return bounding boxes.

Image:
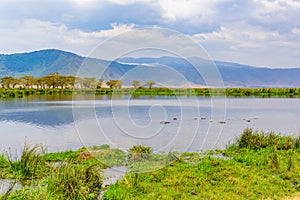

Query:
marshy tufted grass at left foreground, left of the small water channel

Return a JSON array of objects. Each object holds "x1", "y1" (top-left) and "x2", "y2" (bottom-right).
[{"x1": 0, "y1": 143, "x2": 125, "y2": 199}]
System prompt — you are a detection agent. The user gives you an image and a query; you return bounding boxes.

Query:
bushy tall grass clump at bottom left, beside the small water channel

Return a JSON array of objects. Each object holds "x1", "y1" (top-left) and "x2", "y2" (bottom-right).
[{"x1": 7, "y1": 163, "x2": 103, "y2": 200}]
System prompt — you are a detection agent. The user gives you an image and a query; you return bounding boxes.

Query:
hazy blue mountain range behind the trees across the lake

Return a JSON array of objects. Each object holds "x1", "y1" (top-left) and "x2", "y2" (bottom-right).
[{"x1": 0, "y1": 49, "x2": 300, "y2": 87}]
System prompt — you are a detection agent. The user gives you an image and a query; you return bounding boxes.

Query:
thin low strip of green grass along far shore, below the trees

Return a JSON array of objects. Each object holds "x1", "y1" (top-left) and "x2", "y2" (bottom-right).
[{"x1": 0, "y1": 88, "x2": 300, "y2": 99}]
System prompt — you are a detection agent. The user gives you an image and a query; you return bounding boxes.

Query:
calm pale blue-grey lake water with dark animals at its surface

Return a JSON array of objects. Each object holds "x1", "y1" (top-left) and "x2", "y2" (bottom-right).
[{"x1": 0, "y1": 96, "x2": 300, "y2": 151}]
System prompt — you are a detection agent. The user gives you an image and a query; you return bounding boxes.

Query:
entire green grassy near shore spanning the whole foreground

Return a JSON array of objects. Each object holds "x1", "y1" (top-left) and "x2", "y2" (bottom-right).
[{"x1": 0, "y1": 129, "x2": 300, "y2": 199}]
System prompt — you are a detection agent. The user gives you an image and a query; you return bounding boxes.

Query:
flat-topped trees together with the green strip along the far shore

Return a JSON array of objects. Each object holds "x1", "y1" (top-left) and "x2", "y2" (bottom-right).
[{"x1": 0, "y1": 73, "x2": 300, "y2": 98}]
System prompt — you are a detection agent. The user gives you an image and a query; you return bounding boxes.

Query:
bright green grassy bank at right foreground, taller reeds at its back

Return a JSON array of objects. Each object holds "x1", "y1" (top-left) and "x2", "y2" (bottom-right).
[{"x1": 104, "y1": 129, "x2": 300, "y2": 199}]
